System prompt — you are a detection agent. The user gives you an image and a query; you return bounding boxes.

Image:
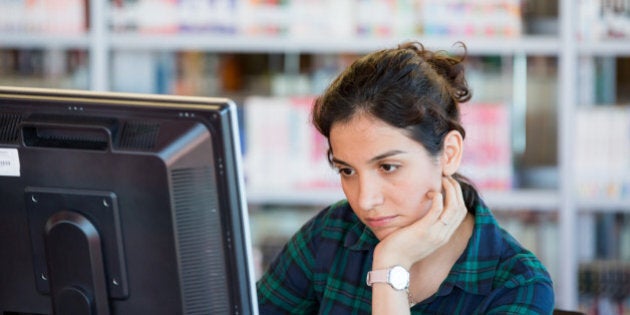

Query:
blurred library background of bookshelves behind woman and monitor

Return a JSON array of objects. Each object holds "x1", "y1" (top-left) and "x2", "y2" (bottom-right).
[{"x1": 0, "y1": 0, "x2": 630, "y2": 314}]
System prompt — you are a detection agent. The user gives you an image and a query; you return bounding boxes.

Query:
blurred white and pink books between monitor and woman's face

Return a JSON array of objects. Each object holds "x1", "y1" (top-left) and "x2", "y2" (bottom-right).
[{"x1": 243, "y1": 96, "x2": 339, "y2": 193}]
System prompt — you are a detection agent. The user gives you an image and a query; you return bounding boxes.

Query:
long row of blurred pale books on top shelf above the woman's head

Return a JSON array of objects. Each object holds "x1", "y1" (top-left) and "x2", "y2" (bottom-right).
[{"x1": 105, "y1": 0, "x2": 523, "y2": 38}]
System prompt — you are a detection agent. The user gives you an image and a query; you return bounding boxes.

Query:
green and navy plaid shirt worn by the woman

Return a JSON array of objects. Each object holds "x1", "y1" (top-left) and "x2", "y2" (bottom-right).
[{"x1": 257, "y1": 201, "x2": 554, "y2": 314}]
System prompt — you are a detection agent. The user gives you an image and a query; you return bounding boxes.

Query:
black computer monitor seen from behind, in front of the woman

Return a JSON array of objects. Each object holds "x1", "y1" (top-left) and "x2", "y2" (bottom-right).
[{"x1": 0, "y1": 87, "x2": 257, "y2": 315}]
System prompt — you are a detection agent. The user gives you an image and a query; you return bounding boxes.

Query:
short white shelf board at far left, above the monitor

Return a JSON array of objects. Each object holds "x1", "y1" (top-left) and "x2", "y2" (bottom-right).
[{"x1": 0, "y1": 32, "x2": 90, "y2": 49}]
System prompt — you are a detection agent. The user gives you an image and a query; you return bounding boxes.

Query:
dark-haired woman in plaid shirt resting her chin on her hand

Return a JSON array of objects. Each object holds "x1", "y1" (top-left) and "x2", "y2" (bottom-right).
[{"x1": 257, "y1": 43, "x2": 554, "y2": 314}]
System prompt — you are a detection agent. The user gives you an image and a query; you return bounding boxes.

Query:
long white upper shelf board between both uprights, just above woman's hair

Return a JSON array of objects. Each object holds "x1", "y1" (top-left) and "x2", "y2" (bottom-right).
[{"x1": 109, "y1": 33, "x2": 560, "y2": 55}]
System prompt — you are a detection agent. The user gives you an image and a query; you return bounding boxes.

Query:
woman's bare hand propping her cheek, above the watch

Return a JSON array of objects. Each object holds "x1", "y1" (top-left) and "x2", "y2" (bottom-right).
[{"x1": 372, "y1": 176, "x2": 467, "y2": 270}]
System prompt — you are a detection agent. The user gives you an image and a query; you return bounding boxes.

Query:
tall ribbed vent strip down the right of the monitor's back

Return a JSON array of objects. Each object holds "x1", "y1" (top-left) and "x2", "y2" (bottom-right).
[{"x1": 171, "y1": 167, "x2": 232, "y2": 314}]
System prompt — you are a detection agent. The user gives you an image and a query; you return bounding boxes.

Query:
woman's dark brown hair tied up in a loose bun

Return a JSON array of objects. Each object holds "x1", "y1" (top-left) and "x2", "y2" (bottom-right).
[{"x1": 312, "y1": 42, "x2": 479, "y2": 211}]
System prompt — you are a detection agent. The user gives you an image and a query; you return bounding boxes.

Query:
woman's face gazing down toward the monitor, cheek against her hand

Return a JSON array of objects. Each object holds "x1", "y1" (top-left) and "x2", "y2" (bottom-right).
[{"x1": 330, "y1": 114, "x2": 442, "y2": 240}]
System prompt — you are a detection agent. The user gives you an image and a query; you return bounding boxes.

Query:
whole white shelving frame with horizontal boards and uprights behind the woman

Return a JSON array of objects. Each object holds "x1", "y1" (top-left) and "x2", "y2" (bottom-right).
[{"x1": 0, "y1": 0, "x2": 630, "y2": 309}]
